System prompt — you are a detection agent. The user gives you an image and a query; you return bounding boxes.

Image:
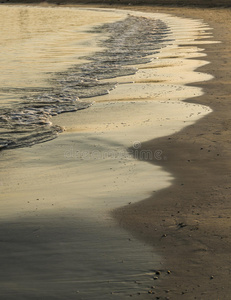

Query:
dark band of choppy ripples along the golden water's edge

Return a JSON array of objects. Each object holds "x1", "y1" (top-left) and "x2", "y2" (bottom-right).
[{"x1": 0, "y1": 15, "x2": 170, "y2": 150}]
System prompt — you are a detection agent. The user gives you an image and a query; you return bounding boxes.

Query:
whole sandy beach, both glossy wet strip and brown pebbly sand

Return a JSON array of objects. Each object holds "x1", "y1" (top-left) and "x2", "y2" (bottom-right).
[{"x1": 1, "y1": 2, "x2": 231, "y2": 299}]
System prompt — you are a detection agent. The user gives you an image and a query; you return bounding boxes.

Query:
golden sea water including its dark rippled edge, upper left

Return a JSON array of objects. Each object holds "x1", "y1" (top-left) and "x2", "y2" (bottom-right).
[{"x1": 0, "y1": 7, "x2": 169, "y2": 149}]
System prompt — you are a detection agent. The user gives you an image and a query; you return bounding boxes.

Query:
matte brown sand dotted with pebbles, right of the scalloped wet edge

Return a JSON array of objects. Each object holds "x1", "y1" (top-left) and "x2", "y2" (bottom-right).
[{"x1": 0, "y1": 2, "x2": 231, "y2": 299}]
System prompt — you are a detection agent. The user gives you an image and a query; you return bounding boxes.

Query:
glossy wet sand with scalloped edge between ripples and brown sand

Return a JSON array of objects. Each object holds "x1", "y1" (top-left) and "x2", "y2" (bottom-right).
[{"x1": 0, "y1": 7, "x2": 215, "y2": 300}]
